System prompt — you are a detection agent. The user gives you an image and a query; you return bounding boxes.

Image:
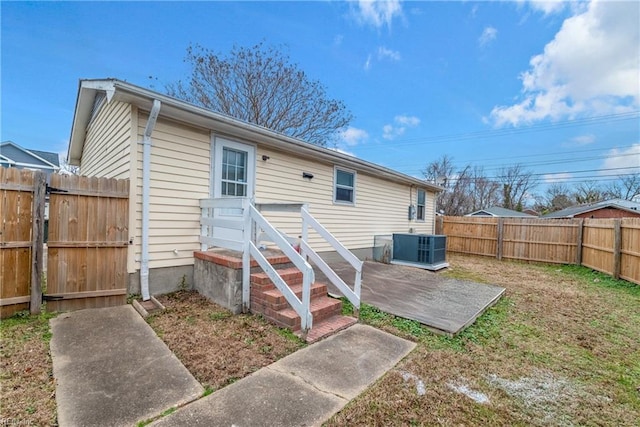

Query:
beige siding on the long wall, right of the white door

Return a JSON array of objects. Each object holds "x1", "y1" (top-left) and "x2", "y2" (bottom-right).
[{"x1": 256, "y1": 147, "x2": 434, "y2": 252}]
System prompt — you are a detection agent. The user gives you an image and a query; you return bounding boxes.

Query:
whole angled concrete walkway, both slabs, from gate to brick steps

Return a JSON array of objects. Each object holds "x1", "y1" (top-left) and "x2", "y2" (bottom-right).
[{"x1": 51, "y1": 305, "x2": 415, "y2": 427}]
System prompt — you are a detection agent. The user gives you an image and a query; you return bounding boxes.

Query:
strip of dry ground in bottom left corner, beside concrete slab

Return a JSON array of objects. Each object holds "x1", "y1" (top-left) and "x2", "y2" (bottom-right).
[{"x1": 0, "y1": 317, "x2": 57, "y2": 426}]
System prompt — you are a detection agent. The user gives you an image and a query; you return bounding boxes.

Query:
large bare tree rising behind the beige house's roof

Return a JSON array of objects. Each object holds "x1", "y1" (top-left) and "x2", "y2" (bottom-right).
[{"x1": 166, "y1": 43, "x2": 353, "y2": 146}]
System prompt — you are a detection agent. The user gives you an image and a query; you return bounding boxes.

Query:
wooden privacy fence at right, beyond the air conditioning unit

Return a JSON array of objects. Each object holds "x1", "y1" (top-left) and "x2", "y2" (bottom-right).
[{"x1": 437, "y1": 216, "x2": 640, "y2": 284}]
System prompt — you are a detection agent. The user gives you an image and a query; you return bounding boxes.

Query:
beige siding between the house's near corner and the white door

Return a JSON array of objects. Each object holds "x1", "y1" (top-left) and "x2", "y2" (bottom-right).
[{"x1": 132, "y1": 112, "x2": 211, "y2": 269}]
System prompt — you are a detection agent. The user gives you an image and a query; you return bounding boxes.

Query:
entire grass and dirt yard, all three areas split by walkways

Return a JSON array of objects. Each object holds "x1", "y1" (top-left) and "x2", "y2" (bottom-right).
[{"x1": 0, "y1": 256, "x2": 640, "y2": 426}]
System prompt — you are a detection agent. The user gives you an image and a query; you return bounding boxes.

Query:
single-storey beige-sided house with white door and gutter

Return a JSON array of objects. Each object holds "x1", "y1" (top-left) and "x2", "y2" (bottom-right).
[{"x1": 67, "y1": 79, "x2": 441, "y2": 294}]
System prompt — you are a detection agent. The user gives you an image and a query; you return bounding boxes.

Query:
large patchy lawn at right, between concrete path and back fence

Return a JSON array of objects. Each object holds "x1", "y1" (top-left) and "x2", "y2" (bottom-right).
[{"x1": 327, "y1": 256, "x2": 640, "y2": 426}]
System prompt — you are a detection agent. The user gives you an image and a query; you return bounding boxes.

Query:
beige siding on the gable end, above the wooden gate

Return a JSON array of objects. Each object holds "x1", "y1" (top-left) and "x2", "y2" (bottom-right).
[{"x1": 80, "y1": 100, "x2": 132, "y2": 179}]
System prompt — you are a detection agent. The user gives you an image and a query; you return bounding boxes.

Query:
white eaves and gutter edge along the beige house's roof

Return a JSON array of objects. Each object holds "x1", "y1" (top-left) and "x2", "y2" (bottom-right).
[{"x1": 67, "y1": 78, "x2": 444, "y2": 192}]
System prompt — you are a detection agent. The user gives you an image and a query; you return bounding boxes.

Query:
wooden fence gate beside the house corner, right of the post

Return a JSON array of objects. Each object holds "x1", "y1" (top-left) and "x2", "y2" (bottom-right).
[{"x1": 44, "y1": 175, "x2": 129, "y2": 311}]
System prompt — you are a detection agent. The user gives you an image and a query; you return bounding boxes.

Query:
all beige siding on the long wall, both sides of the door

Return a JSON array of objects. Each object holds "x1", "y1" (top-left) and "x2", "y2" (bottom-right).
[{"x1": 125, "y1": 116, "x2": 434, "y2": 272}]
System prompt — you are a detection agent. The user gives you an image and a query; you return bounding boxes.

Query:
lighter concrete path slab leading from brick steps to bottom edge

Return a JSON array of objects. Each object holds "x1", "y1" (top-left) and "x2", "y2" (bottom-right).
[{"x1": 151, "y1": 325, "x2": 415, "y2": 427}]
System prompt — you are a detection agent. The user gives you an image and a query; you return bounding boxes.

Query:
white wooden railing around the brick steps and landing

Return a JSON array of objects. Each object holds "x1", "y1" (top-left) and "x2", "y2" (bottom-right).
[{"x1": 200, "y1": 197, "x2": 362, "y2": 336}]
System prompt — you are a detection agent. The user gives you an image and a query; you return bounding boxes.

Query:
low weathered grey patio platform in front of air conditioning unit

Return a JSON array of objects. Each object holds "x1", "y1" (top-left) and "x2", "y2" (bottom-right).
[{"x1": 316, "y1": 261, "x2": 505, "y2": 335}]
